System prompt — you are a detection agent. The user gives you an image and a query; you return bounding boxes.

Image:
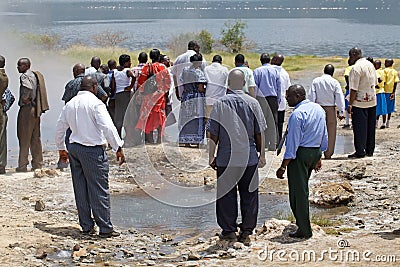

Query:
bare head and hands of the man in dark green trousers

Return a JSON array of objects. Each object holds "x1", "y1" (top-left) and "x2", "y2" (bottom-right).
[{"x1": 276, "y1": 84, "x2": 322, "y2": 179}]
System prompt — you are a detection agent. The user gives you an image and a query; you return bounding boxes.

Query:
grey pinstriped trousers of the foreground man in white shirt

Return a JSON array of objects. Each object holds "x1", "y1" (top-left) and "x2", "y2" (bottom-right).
[{"x1": 68, "y1": 143, "x2": 113, "y2": 233}]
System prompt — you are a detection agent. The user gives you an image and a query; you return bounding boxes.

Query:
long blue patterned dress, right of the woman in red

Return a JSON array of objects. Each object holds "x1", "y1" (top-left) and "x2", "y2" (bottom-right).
[{"x1": 178, "y1": 66, "x2": 207, "y2": 144}]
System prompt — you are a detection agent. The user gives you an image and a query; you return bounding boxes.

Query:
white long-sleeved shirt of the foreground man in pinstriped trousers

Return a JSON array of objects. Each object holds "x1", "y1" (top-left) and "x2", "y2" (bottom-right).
[{"x1": 55, "y1": 91, "x2": 124, "y2": 152}]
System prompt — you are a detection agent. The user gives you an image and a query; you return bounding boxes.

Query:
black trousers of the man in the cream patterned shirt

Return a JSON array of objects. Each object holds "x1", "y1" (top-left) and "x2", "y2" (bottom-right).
[{"x1": 352, "y1": 106, "x2": 376, "y2": 156}]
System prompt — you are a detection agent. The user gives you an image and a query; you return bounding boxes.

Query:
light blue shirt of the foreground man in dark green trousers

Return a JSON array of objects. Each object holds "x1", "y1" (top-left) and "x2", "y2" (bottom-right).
[{"x1": 283, "y1": 100, "x2": 328, "y2": 159}]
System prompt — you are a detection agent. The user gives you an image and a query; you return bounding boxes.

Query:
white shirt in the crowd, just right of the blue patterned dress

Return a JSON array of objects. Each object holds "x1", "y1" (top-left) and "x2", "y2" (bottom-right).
[{"x1": 204, "y1": 62, "x2": 229, "y2": 106}]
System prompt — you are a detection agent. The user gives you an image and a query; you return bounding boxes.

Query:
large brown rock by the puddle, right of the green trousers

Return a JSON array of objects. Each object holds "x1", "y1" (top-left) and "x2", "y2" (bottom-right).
[{"x1": 310, "y1": 182, "x2": 354, "y2": 207}]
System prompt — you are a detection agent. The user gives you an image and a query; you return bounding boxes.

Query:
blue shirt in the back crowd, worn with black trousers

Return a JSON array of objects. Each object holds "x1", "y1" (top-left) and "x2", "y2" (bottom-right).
[{"x1": 254, "y1": 64, "x2": 281, "y2": 104}]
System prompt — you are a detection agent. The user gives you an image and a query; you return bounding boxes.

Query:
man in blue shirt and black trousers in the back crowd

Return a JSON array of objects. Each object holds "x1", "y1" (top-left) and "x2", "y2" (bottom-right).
[{"x1": 254, "y1": 53, "x2": 281, "y2": 150}]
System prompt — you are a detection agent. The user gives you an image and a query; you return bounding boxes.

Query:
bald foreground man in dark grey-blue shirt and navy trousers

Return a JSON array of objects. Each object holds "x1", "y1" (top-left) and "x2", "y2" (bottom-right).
[{"x1": 207, "y1": 69, "x2": 266, "y2": 245}]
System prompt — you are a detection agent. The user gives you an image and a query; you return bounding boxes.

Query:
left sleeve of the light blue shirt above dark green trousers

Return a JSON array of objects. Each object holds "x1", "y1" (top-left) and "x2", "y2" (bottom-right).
[{"x1": 283, "y1": 113, "x2": 303, "y2": 159}]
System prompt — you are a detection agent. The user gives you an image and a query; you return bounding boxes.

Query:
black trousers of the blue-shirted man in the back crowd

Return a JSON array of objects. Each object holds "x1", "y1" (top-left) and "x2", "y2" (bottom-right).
[{"x1": 257, "y1": 96, "x2": 278, "y2": 151}]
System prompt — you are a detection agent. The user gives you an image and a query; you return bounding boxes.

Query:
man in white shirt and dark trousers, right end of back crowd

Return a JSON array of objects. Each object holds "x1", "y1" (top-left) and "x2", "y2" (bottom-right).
[{"x1": 271, "y1": 54, "x2": 292, "y2": 144}]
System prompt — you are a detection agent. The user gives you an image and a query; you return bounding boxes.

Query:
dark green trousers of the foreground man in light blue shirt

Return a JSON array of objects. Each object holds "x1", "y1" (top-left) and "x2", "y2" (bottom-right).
[{"x1": 287, "y1": 147, "x2": 322, "y2": 238}]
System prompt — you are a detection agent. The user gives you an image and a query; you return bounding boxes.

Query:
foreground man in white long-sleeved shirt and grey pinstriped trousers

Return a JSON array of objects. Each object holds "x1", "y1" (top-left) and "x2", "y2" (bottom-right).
[{"x1": 55, "y1": 76, "x2": 125, "y2": 237}]
